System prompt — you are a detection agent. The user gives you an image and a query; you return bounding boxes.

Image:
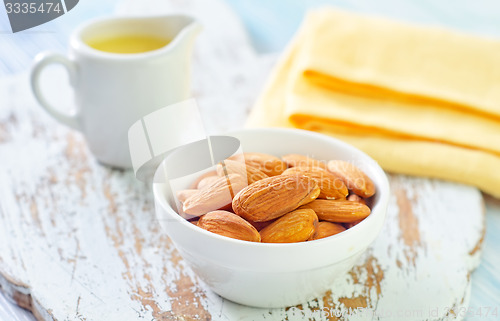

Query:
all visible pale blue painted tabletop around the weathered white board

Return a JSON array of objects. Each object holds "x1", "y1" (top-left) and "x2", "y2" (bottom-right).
[{"x1": 0, "y1": 0, "x2": 500, "y2": 321}]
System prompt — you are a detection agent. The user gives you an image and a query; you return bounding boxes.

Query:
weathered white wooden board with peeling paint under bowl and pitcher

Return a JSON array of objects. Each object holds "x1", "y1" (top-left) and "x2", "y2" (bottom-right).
[{"x1": 0, "y1": 0, "x2": 484, "y2": 321}]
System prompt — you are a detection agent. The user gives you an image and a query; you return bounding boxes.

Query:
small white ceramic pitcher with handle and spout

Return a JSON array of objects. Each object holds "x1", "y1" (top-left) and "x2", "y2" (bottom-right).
[{"x1": 31, "y1": 15, "x2": 201, "y2": 168}]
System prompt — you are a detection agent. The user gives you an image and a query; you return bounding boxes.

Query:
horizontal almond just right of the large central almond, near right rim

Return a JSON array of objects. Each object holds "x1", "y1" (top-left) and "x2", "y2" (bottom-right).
[{"x1": 301, "y1": 200, "x2": 370, "y2": 223}]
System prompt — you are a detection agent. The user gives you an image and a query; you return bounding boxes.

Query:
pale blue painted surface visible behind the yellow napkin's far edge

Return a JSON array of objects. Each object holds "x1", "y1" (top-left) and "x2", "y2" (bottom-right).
[{"x1": 227, "y1": 0, "x2": 500, "y2": 52}]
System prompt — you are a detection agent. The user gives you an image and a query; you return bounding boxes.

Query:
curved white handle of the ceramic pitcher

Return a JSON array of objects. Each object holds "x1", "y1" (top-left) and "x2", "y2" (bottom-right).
[{"x1": 31, "y1": 52, "x2": 81, "y2": 131}]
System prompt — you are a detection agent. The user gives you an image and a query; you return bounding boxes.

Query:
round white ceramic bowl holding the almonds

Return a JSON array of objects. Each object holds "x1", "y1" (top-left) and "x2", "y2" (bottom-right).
[{"x1": 154, "y1": 128, "x2": 389, "y2": 307}]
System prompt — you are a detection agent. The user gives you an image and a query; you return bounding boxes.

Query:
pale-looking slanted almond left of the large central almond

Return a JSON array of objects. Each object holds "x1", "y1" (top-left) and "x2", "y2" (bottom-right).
[{"x1": 183, "y1": 174, "x2": 247, "y2": 215}]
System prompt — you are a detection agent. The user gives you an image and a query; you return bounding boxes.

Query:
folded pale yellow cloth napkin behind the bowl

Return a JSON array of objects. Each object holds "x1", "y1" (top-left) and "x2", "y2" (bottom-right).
[{"x1": 247, "y1": 8, "x2": 500, "y2": 197}]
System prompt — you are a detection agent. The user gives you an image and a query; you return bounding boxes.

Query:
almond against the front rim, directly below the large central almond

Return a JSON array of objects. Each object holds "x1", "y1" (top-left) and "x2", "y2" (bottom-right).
[{"x1": 260, "y1": 209, "x2": 318, "y2": 243}]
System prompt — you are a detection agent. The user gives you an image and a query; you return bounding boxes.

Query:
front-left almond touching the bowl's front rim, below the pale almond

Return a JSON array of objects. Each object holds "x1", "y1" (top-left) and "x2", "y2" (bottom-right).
[{"x1": 198, "y1": 211, "x2": 260, "y2": 242}]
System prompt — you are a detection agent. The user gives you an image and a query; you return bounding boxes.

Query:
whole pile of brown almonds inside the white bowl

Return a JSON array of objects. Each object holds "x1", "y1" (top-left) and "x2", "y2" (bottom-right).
[{"x1": 177, "y1": 153, "x2": 375, "y2": 243}]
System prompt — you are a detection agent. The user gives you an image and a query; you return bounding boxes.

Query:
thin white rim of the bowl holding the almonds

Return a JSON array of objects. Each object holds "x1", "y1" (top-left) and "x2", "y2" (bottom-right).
[{"x1": 153, "y1": 128, "x2": 390, "y2": 249}]
